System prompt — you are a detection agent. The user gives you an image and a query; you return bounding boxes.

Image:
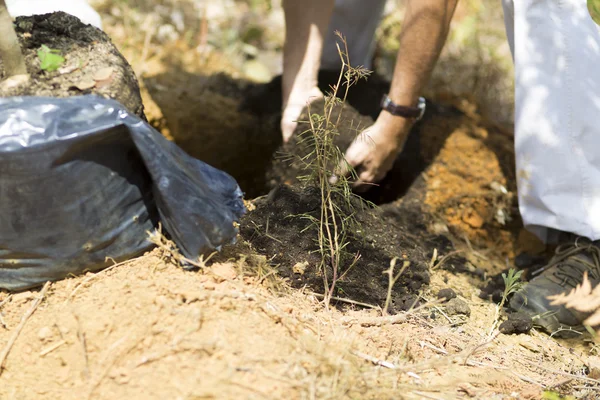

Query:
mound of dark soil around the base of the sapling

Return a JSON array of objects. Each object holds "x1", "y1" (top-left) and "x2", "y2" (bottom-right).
[{"x1": 241, "y1": 185, "x2": 451, "y2": 312}]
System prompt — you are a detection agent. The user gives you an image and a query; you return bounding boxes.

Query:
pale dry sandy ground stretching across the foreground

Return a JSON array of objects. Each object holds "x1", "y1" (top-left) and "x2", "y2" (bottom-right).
[{"x1": 0, "y1": 250, "x2": 598, "y2": 399}]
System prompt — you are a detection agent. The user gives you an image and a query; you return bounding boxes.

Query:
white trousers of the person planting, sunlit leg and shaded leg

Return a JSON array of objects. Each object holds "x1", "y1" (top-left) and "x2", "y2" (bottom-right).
[{"x1": 323, "y1": 0, "x2": 600, "y2": 242}]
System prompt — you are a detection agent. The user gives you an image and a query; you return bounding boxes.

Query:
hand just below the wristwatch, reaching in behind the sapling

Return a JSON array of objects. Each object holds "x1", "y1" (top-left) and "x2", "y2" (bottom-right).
[{"x1": 333, "y1": 112, "x2": 412, "y2": 191}]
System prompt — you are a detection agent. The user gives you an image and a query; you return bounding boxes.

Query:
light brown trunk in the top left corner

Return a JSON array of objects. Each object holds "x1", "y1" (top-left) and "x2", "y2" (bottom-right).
[{"x1": 0, "y1": 0, "x2": 27, "y2": 78}]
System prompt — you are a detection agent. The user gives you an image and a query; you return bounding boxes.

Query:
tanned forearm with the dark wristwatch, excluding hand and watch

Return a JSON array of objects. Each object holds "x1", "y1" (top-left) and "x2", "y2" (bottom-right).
[{"x1": 380, "y1": 0, "x2": 458, "y2": 134}]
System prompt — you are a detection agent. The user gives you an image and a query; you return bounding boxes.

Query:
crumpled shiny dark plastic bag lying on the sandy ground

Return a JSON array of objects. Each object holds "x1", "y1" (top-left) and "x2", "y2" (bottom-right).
[{"x1": 0, "y1": 95, "x2": 246, "y2": 290}]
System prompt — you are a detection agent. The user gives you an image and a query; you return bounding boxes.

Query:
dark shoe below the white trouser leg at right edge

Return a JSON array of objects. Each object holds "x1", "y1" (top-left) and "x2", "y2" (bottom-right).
[{"x1": 510, "y1": 239, "x2": 600, "y2": 336}]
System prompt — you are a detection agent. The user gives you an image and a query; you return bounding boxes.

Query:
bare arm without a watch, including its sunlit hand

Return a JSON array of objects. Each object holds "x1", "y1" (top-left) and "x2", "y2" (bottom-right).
[{"x1": 281, "y1": 0, "x2": 334, "y2": 141}]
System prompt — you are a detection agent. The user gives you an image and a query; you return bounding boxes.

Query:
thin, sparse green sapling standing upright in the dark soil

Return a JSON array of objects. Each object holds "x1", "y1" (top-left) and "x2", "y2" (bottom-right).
[{"x1": 292, "y1": 32, "x2": 370, "y2": 305}]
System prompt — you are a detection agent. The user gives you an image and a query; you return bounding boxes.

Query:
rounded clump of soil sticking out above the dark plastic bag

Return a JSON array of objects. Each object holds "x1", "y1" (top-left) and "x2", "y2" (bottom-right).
[{"x1": 0, "y1": 12, "x2": 144, "y2": 118}]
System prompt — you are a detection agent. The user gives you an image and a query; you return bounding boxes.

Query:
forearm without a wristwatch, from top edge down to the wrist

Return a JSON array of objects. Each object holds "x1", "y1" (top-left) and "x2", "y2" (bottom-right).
[{"x1": 282, "y1": 0, "x2": 334, "y2": 105}]
